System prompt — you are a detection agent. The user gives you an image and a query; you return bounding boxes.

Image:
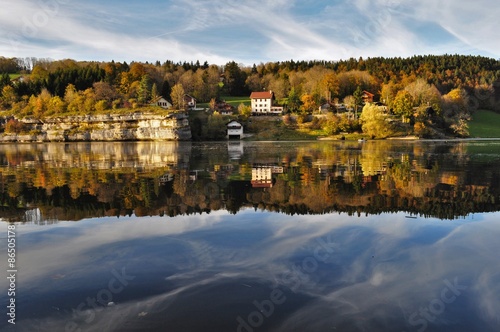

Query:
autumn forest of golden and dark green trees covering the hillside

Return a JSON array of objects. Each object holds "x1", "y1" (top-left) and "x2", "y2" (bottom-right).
[{"x1": 0, "y1": 55, "x2": 500, "y2": 137}]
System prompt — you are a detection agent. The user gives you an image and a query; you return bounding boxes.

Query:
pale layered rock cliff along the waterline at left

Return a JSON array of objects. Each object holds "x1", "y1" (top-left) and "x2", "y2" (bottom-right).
[{"x1": 0, "y1": 113, "x2": 191, "y2": 142}]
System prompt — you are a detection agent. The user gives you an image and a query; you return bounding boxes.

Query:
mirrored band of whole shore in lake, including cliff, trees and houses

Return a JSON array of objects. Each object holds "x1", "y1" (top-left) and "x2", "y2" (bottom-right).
[{"x1": 0, "y1": 142, "x2": 500, "y2": 223}]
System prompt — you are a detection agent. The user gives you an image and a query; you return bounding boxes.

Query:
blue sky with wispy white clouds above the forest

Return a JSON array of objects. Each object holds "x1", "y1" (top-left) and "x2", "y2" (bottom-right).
[{"x1": 0, "y1": 0, "x2": 500, "y2": 65}]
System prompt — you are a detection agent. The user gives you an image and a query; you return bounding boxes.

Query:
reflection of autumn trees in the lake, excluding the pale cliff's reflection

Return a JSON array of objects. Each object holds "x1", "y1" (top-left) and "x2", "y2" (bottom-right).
[{"x1": 0, "y1": 143, "x2": 500, "y2": 220}]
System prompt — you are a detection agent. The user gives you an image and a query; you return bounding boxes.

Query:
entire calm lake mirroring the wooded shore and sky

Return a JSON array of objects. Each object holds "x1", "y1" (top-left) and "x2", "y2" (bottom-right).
[{"x1": 0, "y1": 141, "x2": 500, "y2": 332}]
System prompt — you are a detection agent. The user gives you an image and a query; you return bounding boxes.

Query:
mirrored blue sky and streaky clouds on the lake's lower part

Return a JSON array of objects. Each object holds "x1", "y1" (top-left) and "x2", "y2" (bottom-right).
[{"x1": 0, "y1": 209, "x2": 500, "y2": 331}]
